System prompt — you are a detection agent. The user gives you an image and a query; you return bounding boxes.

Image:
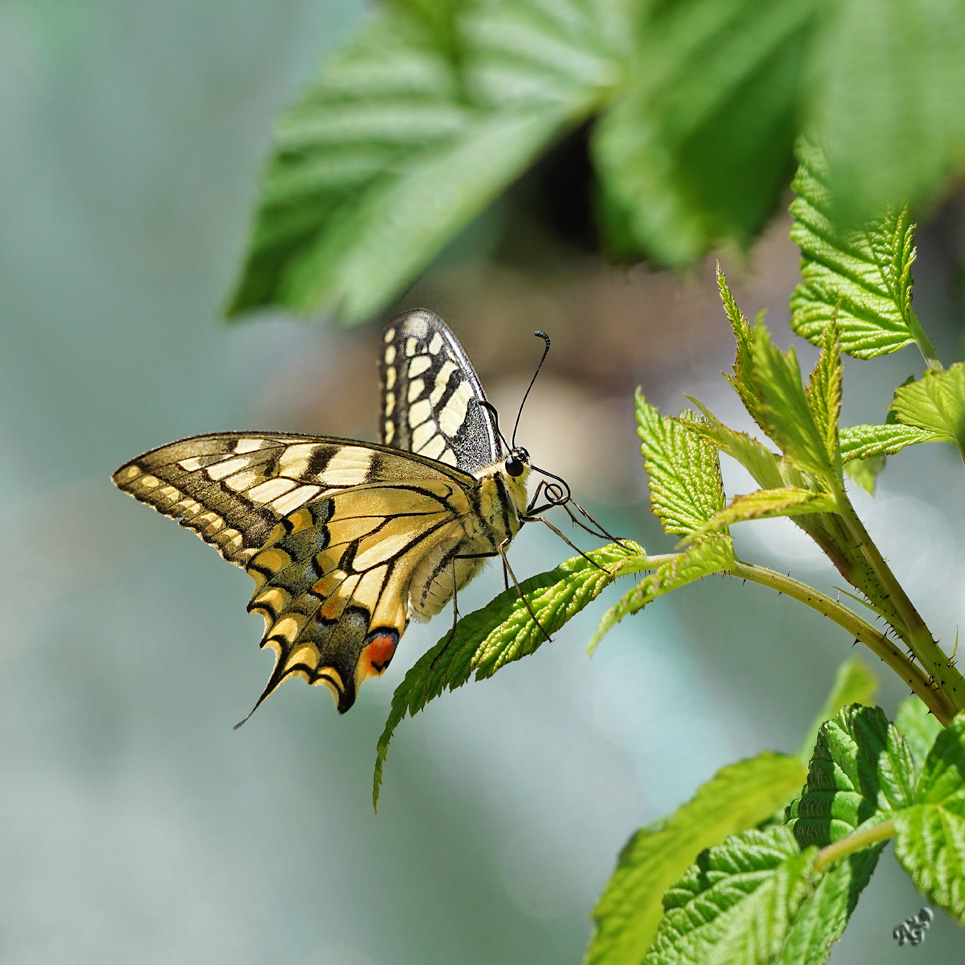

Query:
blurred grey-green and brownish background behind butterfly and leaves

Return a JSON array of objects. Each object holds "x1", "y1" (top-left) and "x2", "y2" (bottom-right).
[{"x1": 0, "y1": 0, "x2": 965, "y2": 965}]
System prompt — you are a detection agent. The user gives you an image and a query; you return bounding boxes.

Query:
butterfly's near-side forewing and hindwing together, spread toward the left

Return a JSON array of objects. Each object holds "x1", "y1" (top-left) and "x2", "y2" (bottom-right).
[{"x1": 114, "y1": 433, "x2": 475, "y2": 713}]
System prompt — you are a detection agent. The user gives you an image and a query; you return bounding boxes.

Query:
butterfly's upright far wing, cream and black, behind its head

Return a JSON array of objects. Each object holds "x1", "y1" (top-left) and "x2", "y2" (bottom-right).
[{"x1": 379, "y1": 309, "x2": 502, "y2": 473}]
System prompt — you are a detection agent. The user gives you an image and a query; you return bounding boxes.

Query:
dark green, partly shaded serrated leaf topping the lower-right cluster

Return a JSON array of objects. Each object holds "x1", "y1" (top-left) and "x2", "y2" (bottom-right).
[{"x1": 788, "y1": 704, "x2": 915, "y2": 847}]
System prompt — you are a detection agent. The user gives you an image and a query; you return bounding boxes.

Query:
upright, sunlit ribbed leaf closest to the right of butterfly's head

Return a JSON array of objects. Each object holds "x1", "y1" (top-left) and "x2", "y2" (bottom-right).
[{"x1": 637, "y1": 389, "x2": 724, "y2": 536}]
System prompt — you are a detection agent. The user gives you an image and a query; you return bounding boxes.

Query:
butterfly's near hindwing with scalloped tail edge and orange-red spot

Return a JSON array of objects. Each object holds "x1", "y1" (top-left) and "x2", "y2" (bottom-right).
[{"x1": 247, "y1": 476, "x2": 476, "y2": 713}]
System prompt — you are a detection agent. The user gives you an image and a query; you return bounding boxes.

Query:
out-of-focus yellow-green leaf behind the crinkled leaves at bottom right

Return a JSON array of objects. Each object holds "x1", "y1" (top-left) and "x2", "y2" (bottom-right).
[{"x1": 585, "y1": 751, "x2": 806, "y2": 965}]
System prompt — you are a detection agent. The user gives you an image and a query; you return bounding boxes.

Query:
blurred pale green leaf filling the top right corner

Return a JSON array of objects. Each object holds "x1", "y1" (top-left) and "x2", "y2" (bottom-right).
[{"x1": 811, "y1": 0, "x2": 965, "y2": 221}]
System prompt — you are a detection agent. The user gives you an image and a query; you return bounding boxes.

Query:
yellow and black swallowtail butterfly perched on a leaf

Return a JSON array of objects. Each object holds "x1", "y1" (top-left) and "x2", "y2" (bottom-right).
[{"x1": 113, "y1": 310, "x2": 556, "y2": 719}]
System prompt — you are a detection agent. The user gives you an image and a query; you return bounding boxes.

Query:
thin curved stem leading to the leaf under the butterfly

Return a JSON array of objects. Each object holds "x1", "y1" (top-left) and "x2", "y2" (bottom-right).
[{"x1": 728, "y1": 562, "x2": 955, "y2": 726}]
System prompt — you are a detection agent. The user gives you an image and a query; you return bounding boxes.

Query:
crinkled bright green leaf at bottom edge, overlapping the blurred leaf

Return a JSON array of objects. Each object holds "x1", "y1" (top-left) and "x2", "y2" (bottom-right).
[{"x1": 643, "y1": 827, "x2": 819, "y2": 965}]
